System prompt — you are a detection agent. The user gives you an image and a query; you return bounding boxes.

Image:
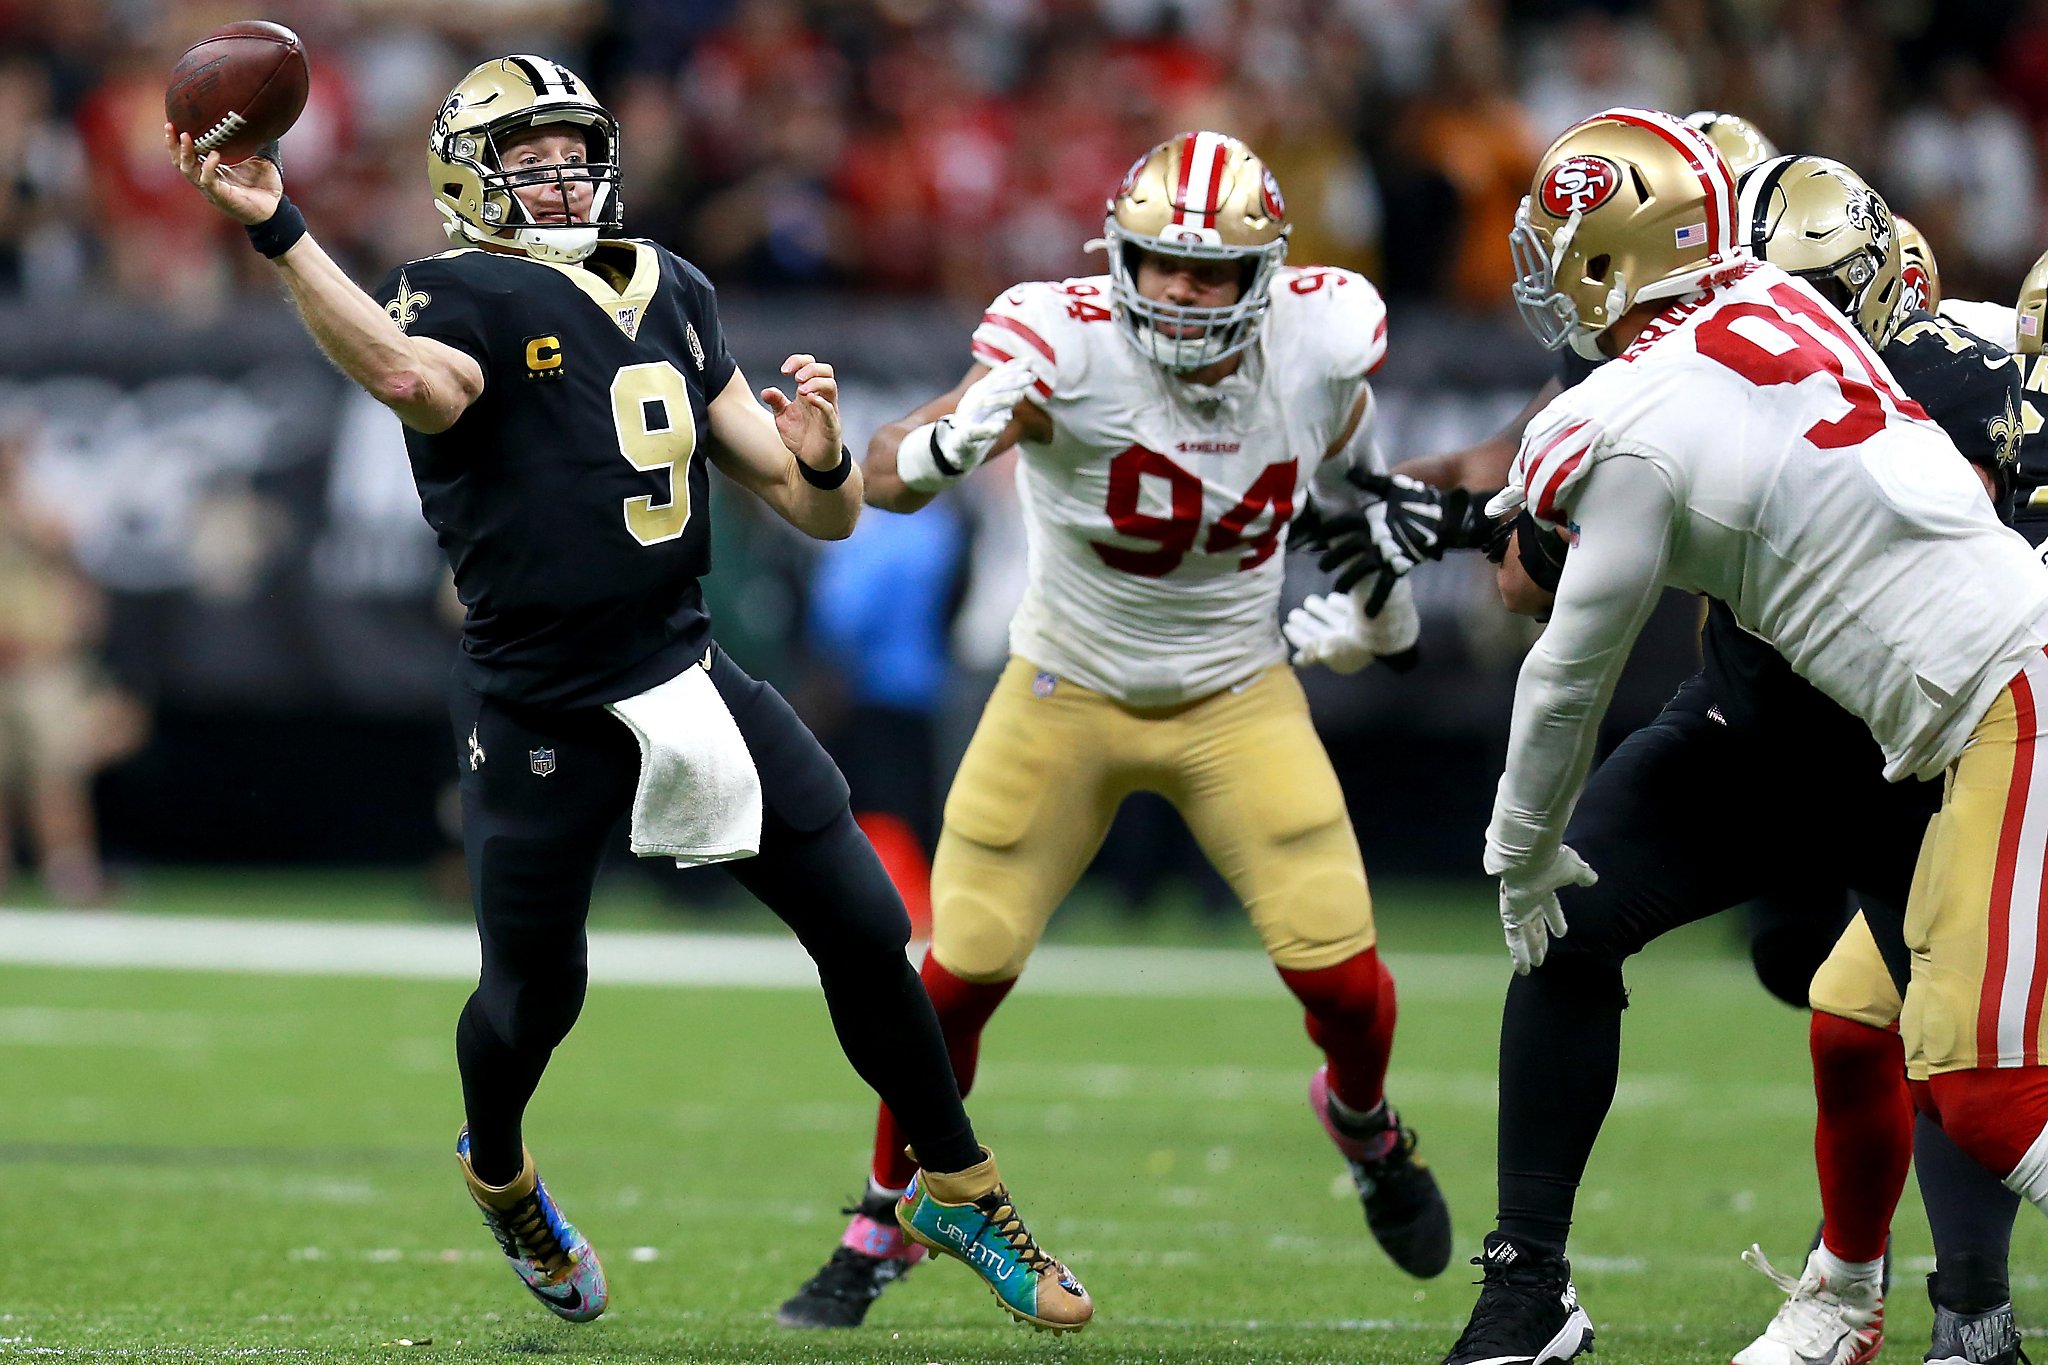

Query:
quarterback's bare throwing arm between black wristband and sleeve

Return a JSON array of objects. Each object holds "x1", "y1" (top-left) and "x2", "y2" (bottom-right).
[{"x1": 274, "y1": 233, "x2": 477, "y2": 432}]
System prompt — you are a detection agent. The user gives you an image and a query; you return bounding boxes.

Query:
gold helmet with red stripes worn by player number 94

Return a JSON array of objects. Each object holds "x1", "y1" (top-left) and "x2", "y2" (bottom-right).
[{"x1": 1090, "y1": 133, "x2": 1292, "y2": 370}]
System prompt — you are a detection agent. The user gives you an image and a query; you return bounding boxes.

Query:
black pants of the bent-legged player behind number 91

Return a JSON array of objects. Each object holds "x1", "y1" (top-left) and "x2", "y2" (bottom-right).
[{"x1": 1499, "y1": 677, "x2": 1937, "y2": 1250}]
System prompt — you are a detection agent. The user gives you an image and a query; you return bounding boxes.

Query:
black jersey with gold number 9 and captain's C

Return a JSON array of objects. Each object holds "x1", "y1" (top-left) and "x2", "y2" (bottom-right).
[{"x1": 375, "y1": 241, "x2": 735, "y2": 706}]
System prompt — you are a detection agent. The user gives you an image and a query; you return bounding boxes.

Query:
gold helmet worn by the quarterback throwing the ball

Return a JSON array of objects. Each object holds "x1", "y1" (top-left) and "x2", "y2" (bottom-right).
[{"x1": 426, "y1": 55, "x2": 623, "y2": 264}]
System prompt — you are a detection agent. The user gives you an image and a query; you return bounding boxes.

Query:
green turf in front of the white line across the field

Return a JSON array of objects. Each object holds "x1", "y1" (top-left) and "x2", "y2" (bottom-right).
[{"x1": 0, "y1": 879, "x2": 2048, "y2": 1365}]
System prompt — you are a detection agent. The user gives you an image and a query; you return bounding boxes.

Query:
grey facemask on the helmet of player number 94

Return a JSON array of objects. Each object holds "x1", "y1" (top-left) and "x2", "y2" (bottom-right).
[{"x1": 1104, "y1": 215, "x2": 1286, "y2": 372}]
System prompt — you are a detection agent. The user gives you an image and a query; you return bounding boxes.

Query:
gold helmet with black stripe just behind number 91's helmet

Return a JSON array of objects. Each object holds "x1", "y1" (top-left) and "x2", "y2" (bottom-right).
[{"x1": 1741, "y1": 156, "x2": 1907, "y2": 350}]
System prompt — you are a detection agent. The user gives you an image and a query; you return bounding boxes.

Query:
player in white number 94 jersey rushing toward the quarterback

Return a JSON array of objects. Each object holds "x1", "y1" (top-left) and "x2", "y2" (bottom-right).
[{"x1": 782, "y1": 133, "x2": 1450, "y2": 1326}]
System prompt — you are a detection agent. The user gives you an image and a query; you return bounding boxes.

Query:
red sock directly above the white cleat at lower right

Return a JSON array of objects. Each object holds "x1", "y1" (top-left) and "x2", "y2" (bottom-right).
[{"x1": 1808, "y1": 1009, "x2": 1913, "y2": 1261}]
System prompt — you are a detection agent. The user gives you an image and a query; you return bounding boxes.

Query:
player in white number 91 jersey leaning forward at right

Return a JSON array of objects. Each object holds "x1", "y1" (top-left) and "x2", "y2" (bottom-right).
[{"x1": 1452, "y1": 111, "x2": 2048, "y2": 1361}]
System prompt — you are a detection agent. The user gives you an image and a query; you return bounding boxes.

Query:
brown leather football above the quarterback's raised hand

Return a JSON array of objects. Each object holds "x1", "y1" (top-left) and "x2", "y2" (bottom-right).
[{"x1": 164, "y1": 18, "x2": 307, "y2": 162}]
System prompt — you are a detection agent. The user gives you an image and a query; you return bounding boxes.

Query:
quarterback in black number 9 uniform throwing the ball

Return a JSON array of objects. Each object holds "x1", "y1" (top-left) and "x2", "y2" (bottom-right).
[{"x1": 164, "y1": 55, "x2": 1092, "y2": 1330}]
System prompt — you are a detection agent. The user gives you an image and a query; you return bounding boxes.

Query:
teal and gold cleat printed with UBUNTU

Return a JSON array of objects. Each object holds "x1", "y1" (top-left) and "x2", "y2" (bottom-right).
[{"x1": 897, "y1": 1148, "x2": 1096, "y2": 1332}]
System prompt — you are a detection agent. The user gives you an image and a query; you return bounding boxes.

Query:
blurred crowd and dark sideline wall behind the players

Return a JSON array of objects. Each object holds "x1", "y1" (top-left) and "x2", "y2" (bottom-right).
[{"x1": 0, "y1": 0, "x2": 2048, "y2": 916}]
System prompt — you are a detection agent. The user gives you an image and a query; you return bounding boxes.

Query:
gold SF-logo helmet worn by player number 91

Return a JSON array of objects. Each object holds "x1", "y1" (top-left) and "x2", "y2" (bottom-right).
[{"x1": 1509, "y1": 108, "x2": 1749, "y2": 360}]
